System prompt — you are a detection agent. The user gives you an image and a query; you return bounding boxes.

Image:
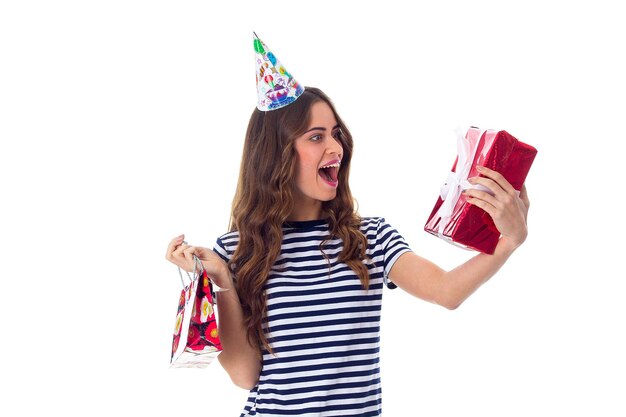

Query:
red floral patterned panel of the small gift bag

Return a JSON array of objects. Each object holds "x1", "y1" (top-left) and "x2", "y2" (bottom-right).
[{"x1": 187, "y1": 271, "x2": 222, "y2": 351}]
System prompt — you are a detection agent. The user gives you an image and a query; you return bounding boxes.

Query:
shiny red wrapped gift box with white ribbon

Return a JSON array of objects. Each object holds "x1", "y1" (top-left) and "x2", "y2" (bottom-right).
[{"x1": 424, "y1": 127, "x2": 537, "y2": 254}]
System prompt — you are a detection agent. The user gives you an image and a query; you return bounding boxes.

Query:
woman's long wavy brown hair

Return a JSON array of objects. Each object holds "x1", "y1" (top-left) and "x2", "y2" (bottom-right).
[{"x1": 228, "y1": 87, "x2": 369, "y2": 353}]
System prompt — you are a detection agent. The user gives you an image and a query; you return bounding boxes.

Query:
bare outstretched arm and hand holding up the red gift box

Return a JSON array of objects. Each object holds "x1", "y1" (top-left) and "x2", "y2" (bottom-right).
[{"x1": 389, "y1": 167, "x2": 530, "y2": 309}]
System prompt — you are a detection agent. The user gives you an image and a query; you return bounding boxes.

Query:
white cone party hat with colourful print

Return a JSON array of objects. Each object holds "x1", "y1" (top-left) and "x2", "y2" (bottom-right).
[{"x1": 252, "y1": 32, "x2": 304, "y2": 111}]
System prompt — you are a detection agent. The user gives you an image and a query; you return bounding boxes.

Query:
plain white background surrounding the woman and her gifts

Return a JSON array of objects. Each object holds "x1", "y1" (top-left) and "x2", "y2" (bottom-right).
[{"x1": 0, "y1": 0, "x2": 626, "y2": 417}]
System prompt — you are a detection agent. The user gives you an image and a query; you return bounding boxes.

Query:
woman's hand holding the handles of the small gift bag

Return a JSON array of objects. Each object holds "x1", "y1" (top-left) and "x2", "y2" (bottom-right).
[{"x1": 165, "y1": 235, "x2": 234, "y2": 290}]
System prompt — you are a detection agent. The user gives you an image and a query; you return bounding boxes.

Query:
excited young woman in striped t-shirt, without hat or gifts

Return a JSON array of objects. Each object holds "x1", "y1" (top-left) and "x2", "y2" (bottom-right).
[{"x1": 166, "y1": 83, "x2": 529, "y2": 416}]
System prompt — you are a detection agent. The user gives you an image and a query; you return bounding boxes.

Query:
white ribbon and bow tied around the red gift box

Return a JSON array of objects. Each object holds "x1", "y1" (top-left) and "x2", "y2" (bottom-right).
[{"x1": 437, "y1": 127, "x2": 493, "y2": 237}]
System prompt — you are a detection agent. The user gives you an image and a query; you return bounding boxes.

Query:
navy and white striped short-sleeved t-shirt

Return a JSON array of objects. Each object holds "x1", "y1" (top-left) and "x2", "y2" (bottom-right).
[{"x1": 213, "y1": 217, "x2": 411, "y2": 417}]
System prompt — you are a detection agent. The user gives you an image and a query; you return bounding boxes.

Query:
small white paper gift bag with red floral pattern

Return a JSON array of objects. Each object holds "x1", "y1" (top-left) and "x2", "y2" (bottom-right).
[{"x1": 170, "y1": 255, "x2": 222, "y2": 368}]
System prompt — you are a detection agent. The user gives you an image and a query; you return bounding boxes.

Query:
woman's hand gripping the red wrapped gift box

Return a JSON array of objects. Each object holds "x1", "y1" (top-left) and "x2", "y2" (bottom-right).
[{"x1": 464, "y1": 167, "x2": 530, "y2": 248}]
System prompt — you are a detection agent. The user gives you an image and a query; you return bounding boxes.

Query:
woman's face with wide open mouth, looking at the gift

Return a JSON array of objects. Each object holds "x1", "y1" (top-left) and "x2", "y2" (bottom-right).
[{"x1": 294, "y1": 101, "x2": 343, "y2": 214}]
